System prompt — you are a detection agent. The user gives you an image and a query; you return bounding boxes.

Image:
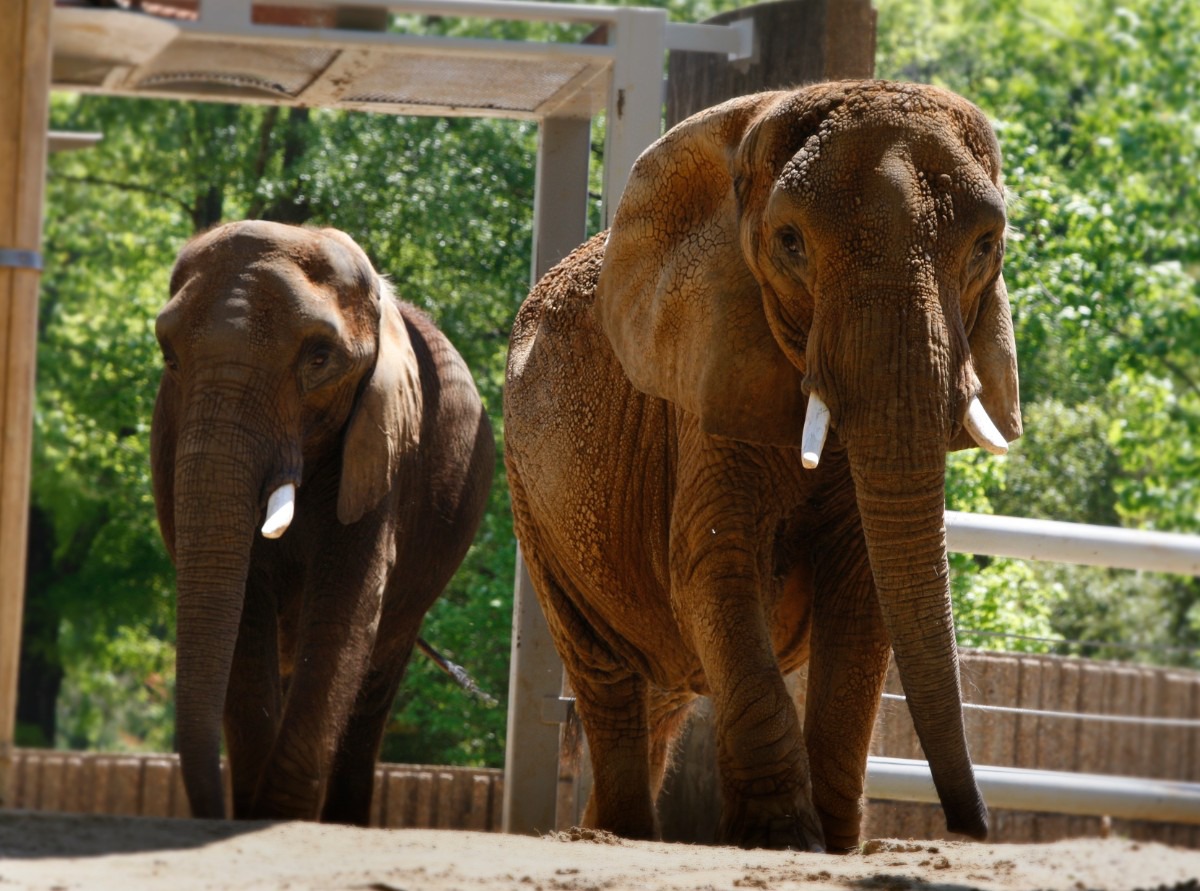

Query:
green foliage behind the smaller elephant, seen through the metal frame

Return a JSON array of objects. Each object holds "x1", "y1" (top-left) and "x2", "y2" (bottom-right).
[{"x1": 34, "y1": 97, "x2": 536, "y2": 765}]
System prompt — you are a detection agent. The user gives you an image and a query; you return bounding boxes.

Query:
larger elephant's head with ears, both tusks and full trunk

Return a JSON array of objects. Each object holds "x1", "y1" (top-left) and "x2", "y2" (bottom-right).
[{"x1": 596, "y1": 82, "x2": 1021, "y2": 837}]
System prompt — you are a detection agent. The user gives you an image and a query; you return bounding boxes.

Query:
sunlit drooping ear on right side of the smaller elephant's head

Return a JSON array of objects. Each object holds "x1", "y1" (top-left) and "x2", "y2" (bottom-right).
[{"x1": 337, "y1": 282, "x2": 421, "y2": 524}]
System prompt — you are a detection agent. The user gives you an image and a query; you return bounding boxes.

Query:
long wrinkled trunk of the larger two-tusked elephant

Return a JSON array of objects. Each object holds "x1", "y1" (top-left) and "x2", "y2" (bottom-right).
[{"x1": 814, "y1": 297, "x2": 988, "y2": 838}]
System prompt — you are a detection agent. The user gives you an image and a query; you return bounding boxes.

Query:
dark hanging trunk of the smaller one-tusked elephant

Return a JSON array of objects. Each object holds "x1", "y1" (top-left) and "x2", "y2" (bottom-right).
[{"x1": 175, "y1": 421, "x2": 262, "y2": 819}]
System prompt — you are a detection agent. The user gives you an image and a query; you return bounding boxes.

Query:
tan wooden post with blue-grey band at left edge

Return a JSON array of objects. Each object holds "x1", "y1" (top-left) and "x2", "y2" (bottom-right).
[{"x1": 0, "y1": 0, "x2": 53, "y2": 807}]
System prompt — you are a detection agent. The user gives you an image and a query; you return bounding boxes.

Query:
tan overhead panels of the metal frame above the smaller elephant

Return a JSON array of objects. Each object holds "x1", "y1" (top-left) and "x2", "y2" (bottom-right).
[{"x1": 52, "y1": 7, "x2": 612, "y2": 119}]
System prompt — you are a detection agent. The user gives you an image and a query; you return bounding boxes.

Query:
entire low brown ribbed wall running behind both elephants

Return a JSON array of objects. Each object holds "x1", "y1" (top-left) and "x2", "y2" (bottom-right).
[{"x1": 13, "y1": 651, "x2": 1200, "y2": 848}]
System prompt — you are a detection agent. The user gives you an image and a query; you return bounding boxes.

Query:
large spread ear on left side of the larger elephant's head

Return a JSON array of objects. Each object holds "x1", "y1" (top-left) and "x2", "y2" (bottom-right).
[{"x1": 595, "y1": 92, "x2": 805, "y2": 446}]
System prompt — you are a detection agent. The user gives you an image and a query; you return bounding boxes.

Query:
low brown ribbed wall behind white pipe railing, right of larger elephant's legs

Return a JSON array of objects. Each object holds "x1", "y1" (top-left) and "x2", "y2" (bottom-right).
[{"x1": 864, "y1": 651, "x2": 1200, "y2": 848}]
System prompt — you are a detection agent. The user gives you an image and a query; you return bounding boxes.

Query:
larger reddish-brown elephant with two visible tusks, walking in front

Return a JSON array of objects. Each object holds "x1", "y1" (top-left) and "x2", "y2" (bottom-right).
[{"x1": 504, "y1": 80, "x2": 1021, "y2": 851}]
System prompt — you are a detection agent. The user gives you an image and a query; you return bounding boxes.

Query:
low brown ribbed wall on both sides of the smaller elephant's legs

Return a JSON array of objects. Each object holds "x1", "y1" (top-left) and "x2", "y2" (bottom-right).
[{"x1": 4, "y1": 749, "x2": 504, "y2": 832}]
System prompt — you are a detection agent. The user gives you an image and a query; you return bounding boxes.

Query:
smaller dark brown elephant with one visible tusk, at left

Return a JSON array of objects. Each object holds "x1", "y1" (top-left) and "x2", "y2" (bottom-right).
[{"x1": 151, "y1": 221, "x2": 496, "y2": 825}]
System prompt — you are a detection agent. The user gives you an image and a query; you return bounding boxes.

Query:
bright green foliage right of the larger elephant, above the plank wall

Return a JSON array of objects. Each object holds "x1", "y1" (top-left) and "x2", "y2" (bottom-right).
[{"x1": 877, "y1": 0, "x2": 1200, "y2": 660}]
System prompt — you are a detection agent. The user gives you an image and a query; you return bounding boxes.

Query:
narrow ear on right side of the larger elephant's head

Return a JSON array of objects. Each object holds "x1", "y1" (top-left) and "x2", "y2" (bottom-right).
[{"x1": 950, "y1": 274, "x2": 1022, "y2": 450}]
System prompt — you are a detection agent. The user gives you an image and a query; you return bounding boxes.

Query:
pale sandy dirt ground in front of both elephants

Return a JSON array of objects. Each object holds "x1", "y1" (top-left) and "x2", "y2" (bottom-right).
[{"x1": 0, "y1": 811, "x2": 1200, "y2": 891}]
